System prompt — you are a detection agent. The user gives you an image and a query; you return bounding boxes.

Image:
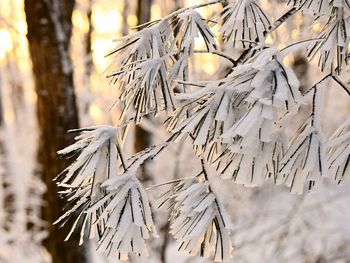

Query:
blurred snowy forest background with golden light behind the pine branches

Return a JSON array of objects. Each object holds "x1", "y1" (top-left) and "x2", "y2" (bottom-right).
[{"x1": 0, "y1": 0, "x2": 350, "y2": 263}]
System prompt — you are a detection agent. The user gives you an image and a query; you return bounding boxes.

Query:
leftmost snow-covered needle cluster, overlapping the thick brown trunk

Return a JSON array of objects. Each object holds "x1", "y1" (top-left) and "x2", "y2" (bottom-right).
[{"x1": 55, "y1": 126, "x2": 125, "y2": 243}]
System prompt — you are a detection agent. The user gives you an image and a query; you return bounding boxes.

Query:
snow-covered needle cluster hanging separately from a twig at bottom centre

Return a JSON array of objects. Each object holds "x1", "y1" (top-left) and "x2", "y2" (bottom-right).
[{"x1": 158, "y1": 167, "x2": 233, "y2": 262}]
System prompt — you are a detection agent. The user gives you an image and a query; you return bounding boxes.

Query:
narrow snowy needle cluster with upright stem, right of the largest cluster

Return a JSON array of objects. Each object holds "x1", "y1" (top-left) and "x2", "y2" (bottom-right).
[{"x1": 279, "y1": 85, "x2": 328, "y2": 193}]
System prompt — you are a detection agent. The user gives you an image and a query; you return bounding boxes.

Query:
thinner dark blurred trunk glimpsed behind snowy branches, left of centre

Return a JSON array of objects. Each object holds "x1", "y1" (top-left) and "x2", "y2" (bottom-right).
[{"x1": 134, "y1": 0, "x2": 152, "y2": 182}]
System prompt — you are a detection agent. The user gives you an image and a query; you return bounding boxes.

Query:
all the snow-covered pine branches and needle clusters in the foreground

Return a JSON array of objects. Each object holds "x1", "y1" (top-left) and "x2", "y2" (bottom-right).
[{"x1": 56, "y1": 0, "x2": 350, "y2": 261}]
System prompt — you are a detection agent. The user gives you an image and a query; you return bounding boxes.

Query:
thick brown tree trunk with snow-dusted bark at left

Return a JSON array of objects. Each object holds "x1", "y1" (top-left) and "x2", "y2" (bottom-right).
[{"x1": 25, "y1": 0, "x2": 86, "y2": 263}]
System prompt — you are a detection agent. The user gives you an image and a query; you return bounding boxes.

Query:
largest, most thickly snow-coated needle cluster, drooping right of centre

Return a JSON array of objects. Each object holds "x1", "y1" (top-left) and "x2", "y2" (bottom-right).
[{"x1": 214, "y1": 48, "x2": 302, "y2": 185}]
